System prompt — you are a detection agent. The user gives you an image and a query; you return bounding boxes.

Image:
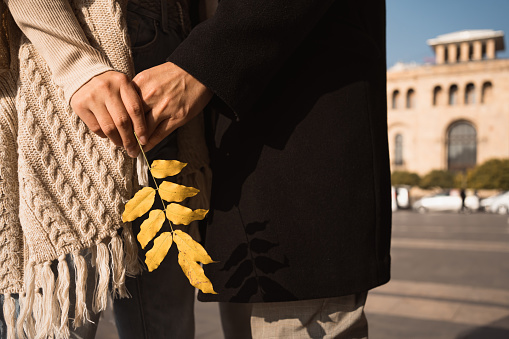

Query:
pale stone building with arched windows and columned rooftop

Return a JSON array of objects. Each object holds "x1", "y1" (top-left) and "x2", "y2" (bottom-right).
[{"x1": 387, "y1": 30, "x2": 509, "y2": 175}]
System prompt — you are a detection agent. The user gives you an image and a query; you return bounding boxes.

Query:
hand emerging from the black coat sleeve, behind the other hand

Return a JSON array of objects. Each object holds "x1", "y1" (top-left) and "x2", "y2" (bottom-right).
[{"x1": 133, "y1": 62, "x2": 213, "y2": 151}]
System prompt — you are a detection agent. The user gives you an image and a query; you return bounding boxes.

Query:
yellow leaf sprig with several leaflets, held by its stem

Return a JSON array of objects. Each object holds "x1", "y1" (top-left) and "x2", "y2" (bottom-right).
[{"x1": 122, "y1": 133, "x2": 216, "y2": 294}]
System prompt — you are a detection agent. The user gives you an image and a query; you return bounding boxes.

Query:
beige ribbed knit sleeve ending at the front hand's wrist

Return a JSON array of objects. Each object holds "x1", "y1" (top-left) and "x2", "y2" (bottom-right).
[{"x1": 5, "y1": 0, "x2": 113, "y2": 101}]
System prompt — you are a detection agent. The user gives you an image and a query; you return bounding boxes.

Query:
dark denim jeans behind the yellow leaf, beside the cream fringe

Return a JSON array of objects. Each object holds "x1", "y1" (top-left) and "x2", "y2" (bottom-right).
[{"x1": 113, "y1": 3, "x2": 195, "y2": 339}]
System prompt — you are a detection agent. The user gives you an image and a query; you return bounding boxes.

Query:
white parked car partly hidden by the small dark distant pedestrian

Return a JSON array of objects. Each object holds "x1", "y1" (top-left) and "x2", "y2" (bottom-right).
[{"x1": 412, "y1": 190, "x2": 479, "y2": 213}]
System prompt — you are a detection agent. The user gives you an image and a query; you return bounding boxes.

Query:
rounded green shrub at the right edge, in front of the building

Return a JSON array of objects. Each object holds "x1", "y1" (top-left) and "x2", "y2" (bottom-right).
[{"x1": 468, "y1": 159, "x2": 509, "y2": 190}]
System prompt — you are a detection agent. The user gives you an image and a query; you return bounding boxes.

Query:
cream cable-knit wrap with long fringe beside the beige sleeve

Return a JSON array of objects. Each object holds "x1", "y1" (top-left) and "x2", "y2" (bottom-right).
[{"x1": 0, "y1": 0, "x2": 210, "y2": 339}]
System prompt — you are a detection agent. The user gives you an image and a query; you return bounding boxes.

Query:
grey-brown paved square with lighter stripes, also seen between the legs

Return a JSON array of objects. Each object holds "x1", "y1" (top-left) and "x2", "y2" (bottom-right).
[{"x1": 96, "y1": 211, "x2": 509, "y2": 339}]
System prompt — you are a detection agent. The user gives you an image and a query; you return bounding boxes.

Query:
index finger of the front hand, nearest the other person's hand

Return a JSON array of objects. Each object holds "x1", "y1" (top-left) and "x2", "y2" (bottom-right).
[{"x1": 120, "y1": 82, "x2": 150, "y2": 145}]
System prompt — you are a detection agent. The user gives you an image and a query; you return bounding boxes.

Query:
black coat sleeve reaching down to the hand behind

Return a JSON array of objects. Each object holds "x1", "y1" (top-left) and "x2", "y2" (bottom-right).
[{"x1": 168, "y1": 0, "x2": 334, "y2": 119}]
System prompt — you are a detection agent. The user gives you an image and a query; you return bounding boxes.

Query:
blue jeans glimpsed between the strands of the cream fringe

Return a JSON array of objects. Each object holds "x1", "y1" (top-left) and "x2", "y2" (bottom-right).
[{"x1": 0, "y1": 252, "x2": 100, "y2": 339}]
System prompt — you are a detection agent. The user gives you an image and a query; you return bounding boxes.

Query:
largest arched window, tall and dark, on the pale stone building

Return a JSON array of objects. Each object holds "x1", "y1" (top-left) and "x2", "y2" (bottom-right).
[{"x1": 447, "y1": 121, "x2": 477, "y2": 171}]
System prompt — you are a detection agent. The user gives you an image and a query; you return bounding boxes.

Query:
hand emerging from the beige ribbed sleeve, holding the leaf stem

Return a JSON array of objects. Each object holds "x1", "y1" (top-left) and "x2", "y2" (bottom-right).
[{"x1": 71, "y1": 71, "x2": 147, "y2": 158}]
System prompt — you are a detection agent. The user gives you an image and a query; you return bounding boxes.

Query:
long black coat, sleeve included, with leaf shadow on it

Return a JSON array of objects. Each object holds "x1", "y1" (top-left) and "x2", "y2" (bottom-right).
[{"x1": 169, "y1": 0, "x2": 391, "y2": 302}]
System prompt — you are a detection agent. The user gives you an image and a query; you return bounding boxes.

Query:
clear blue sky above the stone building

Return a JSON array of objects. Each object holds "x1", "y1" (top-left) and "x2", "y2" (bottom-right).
[{"x1": 386, "y1": 0, "x2": 509, "y2": 67}]
